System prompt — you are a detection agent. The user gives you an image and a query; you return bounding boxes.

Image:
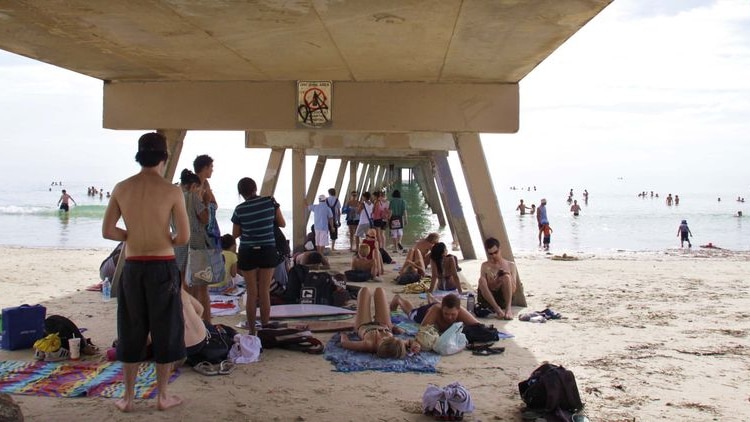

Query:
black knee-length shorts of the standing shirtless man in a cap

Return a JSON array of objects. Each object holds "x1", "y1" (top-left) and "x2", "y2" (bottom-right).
[{"x1": 117, "y1": 257, "x2": 185, "y2": 363}]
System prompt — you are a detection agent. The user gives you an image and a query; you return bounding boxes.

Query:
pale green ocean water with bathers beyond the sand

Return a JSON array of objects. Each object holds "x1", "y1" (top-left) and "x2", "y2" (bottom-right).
[{"x1": 0, "y1": 181, "x2": 750, "y2": 257}]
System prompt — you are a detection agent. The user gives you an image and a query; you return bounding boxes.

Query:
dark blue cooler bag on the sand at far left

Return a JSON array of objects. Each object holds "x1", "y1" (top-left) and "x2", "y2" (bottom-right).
[{"x1": 2, "y1": 305, "x2": 47, "y2": 350}]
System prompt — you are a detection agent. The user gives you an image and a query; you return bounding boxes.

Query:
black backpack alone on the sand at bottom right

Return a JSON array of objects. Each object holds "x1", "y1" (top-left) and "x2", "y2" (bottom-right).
[{"x1": 518, "y1": 363, "x2": 583, "y2": 413}]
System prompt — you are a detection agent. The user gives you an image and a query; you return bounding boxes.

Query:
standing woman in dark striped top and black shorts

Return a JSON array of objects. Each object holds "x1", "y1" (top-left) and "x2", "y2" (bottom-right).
[{"x1": 232, "y1": 177, "x2": 286, "y2": 335}]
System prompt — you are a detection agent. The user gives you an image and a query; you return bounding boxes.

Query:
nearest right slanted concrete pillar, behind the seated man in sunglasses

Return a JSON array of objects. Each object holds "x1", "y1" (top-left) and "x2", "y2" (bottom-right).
[{"x1": 454, "y1": 133, "x2": 526, "y2": 306}]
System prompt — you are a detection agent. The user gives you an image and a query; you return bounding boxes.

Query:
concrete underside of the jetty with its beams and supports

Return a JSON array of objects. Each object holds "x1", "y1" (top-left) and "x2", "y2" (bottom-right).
[{"x1": 0, "y1": 0, "x2": 612, "y2": 305}]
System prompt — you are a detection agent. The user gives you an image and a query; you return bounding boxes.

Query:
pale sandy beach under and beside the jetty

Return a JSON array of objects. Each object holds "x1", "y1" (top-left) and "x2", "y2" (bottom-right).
[{"x1": 0, "y1": 247, "x2": 750, "y2": 421}]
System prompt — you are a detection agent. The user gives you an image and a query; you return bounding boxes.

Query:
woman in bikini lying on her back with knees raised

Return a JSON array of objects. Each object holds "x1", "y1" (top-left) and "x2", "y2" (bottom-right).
[{"x1": 341, "y1": 287, "x2": 422, "y2": 359}]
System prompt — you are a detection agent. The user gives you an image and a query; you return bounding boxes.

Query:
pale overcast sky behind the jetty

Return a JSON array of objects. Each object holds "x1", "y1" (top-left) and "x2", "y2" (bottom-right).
[{"x1": 0, "y1": 0, "x2": 750, "y2": 202}]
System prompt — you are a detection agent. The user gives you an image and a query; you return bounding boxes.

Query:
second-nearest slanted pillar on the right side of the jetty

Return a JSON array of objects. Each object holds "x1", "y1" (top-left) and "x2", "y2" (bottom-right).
[{"x1": 432, "y1": 152, "x2": 477, "y2": 259}]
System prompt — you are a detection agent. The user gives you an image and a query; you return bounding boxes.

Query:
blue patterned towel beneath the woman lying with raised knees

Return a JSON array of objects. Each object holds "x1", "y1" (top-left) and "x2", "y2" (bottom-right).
[{"x1": 325, "y1": 333, "x2": 440, "y2": 372}]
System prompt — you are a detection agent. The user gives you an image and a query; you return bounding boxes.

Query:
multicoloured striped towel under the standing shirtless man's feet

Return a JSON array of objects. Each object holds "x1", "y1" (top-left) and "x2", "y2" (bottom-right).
[{"x1": 0, "y1": 360, "x2": 179, "y2": 399}]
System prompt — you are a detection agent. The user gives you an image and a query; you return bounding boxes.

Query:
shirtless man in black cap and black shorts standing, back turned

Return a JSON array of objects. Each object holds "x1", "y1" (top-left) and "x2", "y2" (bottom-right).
[{"x1": 102, "y1": 132, "x2": 190, "y2": 412}]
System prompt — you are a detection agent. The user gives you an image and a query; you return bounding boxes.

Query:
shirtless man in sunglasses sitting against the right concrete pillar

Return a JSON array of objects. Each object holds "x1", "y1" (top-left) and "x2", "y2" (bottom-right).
[{"x1": 477, "y1": 237, "x2": 516, "y2": 320}]
